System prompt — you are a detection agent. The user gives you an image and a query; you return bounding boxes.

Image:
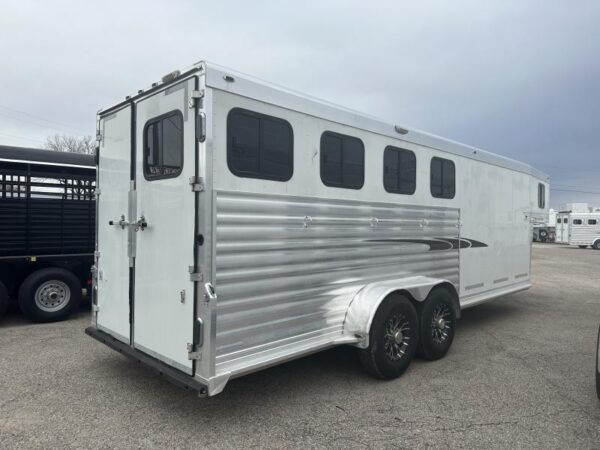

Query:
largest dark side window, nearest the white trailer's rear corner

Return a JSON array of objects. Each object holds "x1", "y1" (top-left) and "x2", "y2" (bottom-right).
[{"x1": 227, "y1": 108, "x2": 294, "y2": 181}]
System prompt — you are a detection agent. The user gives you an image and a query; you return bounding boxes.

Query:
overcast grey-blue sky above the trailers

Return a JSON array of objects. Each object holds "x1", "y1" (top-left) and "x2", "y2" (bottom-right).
[{"x1": 0, "y1": 0, "x2": 600, "y2": 207}]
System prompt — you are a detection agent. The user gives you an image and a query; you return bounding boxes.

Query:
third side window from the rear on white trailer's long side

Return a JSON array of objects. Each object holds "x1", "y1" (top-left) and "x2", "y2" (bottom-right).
[{"x1": 383, "y1": 146, "x2": 417, "y2": 195}]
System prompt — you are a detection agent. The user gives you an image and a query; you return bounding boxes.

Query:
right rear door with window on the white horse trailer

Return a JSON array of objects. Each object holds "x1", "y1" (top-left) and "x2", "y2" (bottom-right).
[{"x1": 130, "y1": 77, "x2": 196, "y2": 374}]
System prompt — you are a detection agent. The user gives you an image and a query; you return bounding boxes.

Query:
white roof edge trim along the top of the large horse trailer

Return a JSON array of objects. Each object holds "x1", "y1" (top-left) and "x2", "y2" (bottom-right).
[{"x1": 98, "y1": 61, "x2": 550, "y2": 181}]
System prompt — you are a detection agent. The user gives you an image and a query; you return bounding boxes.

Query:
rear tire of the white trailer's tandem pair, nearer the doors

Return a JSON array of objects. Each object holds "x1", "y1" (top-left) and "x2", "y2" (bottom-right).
[{"x1": 359, "y1": 294, "x2": 419, "y2": 380}]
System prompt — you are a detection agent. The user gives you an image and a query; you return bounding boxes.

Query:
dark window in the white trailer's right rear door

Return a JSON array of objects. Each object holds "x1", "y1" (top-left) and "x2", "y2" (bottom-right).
[{"x1": 144, "y1": 111, "x2": 183, "y2": 180}]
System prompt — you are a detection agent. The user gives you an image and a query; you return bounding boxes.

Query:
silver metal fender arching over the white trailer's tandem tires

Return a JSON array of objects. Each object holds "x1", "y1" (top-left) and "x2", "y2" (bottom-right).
[{"x1": 343, "y1": 276, "x2": 460, "y2": 348}]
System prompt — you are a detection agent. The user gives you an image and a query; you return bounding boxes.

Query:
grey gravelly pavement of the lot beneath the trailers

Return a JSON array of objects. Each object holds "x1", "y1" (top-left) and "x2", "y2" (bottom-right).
[{"x1": 0, "y1": 244, "x2": 600, "y2": 449}]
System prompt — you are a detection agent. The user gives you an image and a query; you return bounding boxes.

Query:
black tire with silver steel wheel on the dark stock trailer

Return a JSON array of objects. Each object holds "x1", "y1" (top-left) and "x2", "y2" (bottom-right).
[{"x1": 19, "y1": 267, "x2": 82, "y2": 322}]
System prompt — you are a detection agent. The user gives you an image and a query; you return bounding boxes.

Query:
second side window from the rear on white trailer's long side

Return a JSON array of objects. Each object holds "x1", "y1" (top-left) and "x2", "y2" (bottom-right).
[{"x1": 321, "y1": 131, "x2": 365, "y2": 189}]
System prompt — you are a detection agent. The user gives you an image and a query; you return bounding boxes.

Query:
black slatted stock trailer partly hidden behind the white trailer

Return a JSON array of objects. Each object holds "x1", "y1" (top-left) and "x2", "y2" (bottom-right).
[{"x1": 0, "y1": 146, "x2": 96, "y2": 322}]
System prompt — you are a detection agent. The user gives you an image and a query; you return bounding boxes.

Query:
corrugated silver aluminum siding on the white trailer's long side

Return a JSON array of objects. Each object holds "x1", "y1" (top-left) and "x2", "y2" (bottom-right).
[{"x1": 215, "y1": 192, "x2": 459, "y2": 367}]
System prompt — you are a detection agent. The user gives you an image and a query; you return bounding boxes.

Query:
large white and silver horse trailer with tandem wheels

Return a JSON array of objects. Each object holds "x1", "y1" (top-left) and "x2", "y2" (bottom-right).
[{"x1": 86, "y1": 62, "x2": 548, "y2": 395}]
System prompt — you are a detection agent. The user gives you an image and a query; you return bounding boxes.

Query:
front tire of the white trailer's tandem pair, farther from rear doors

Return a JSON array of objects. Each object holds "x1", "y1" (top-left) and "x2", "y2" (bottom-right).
[{"x1": 419, "y1": 287, "x2": 456, "y2": 361}]
